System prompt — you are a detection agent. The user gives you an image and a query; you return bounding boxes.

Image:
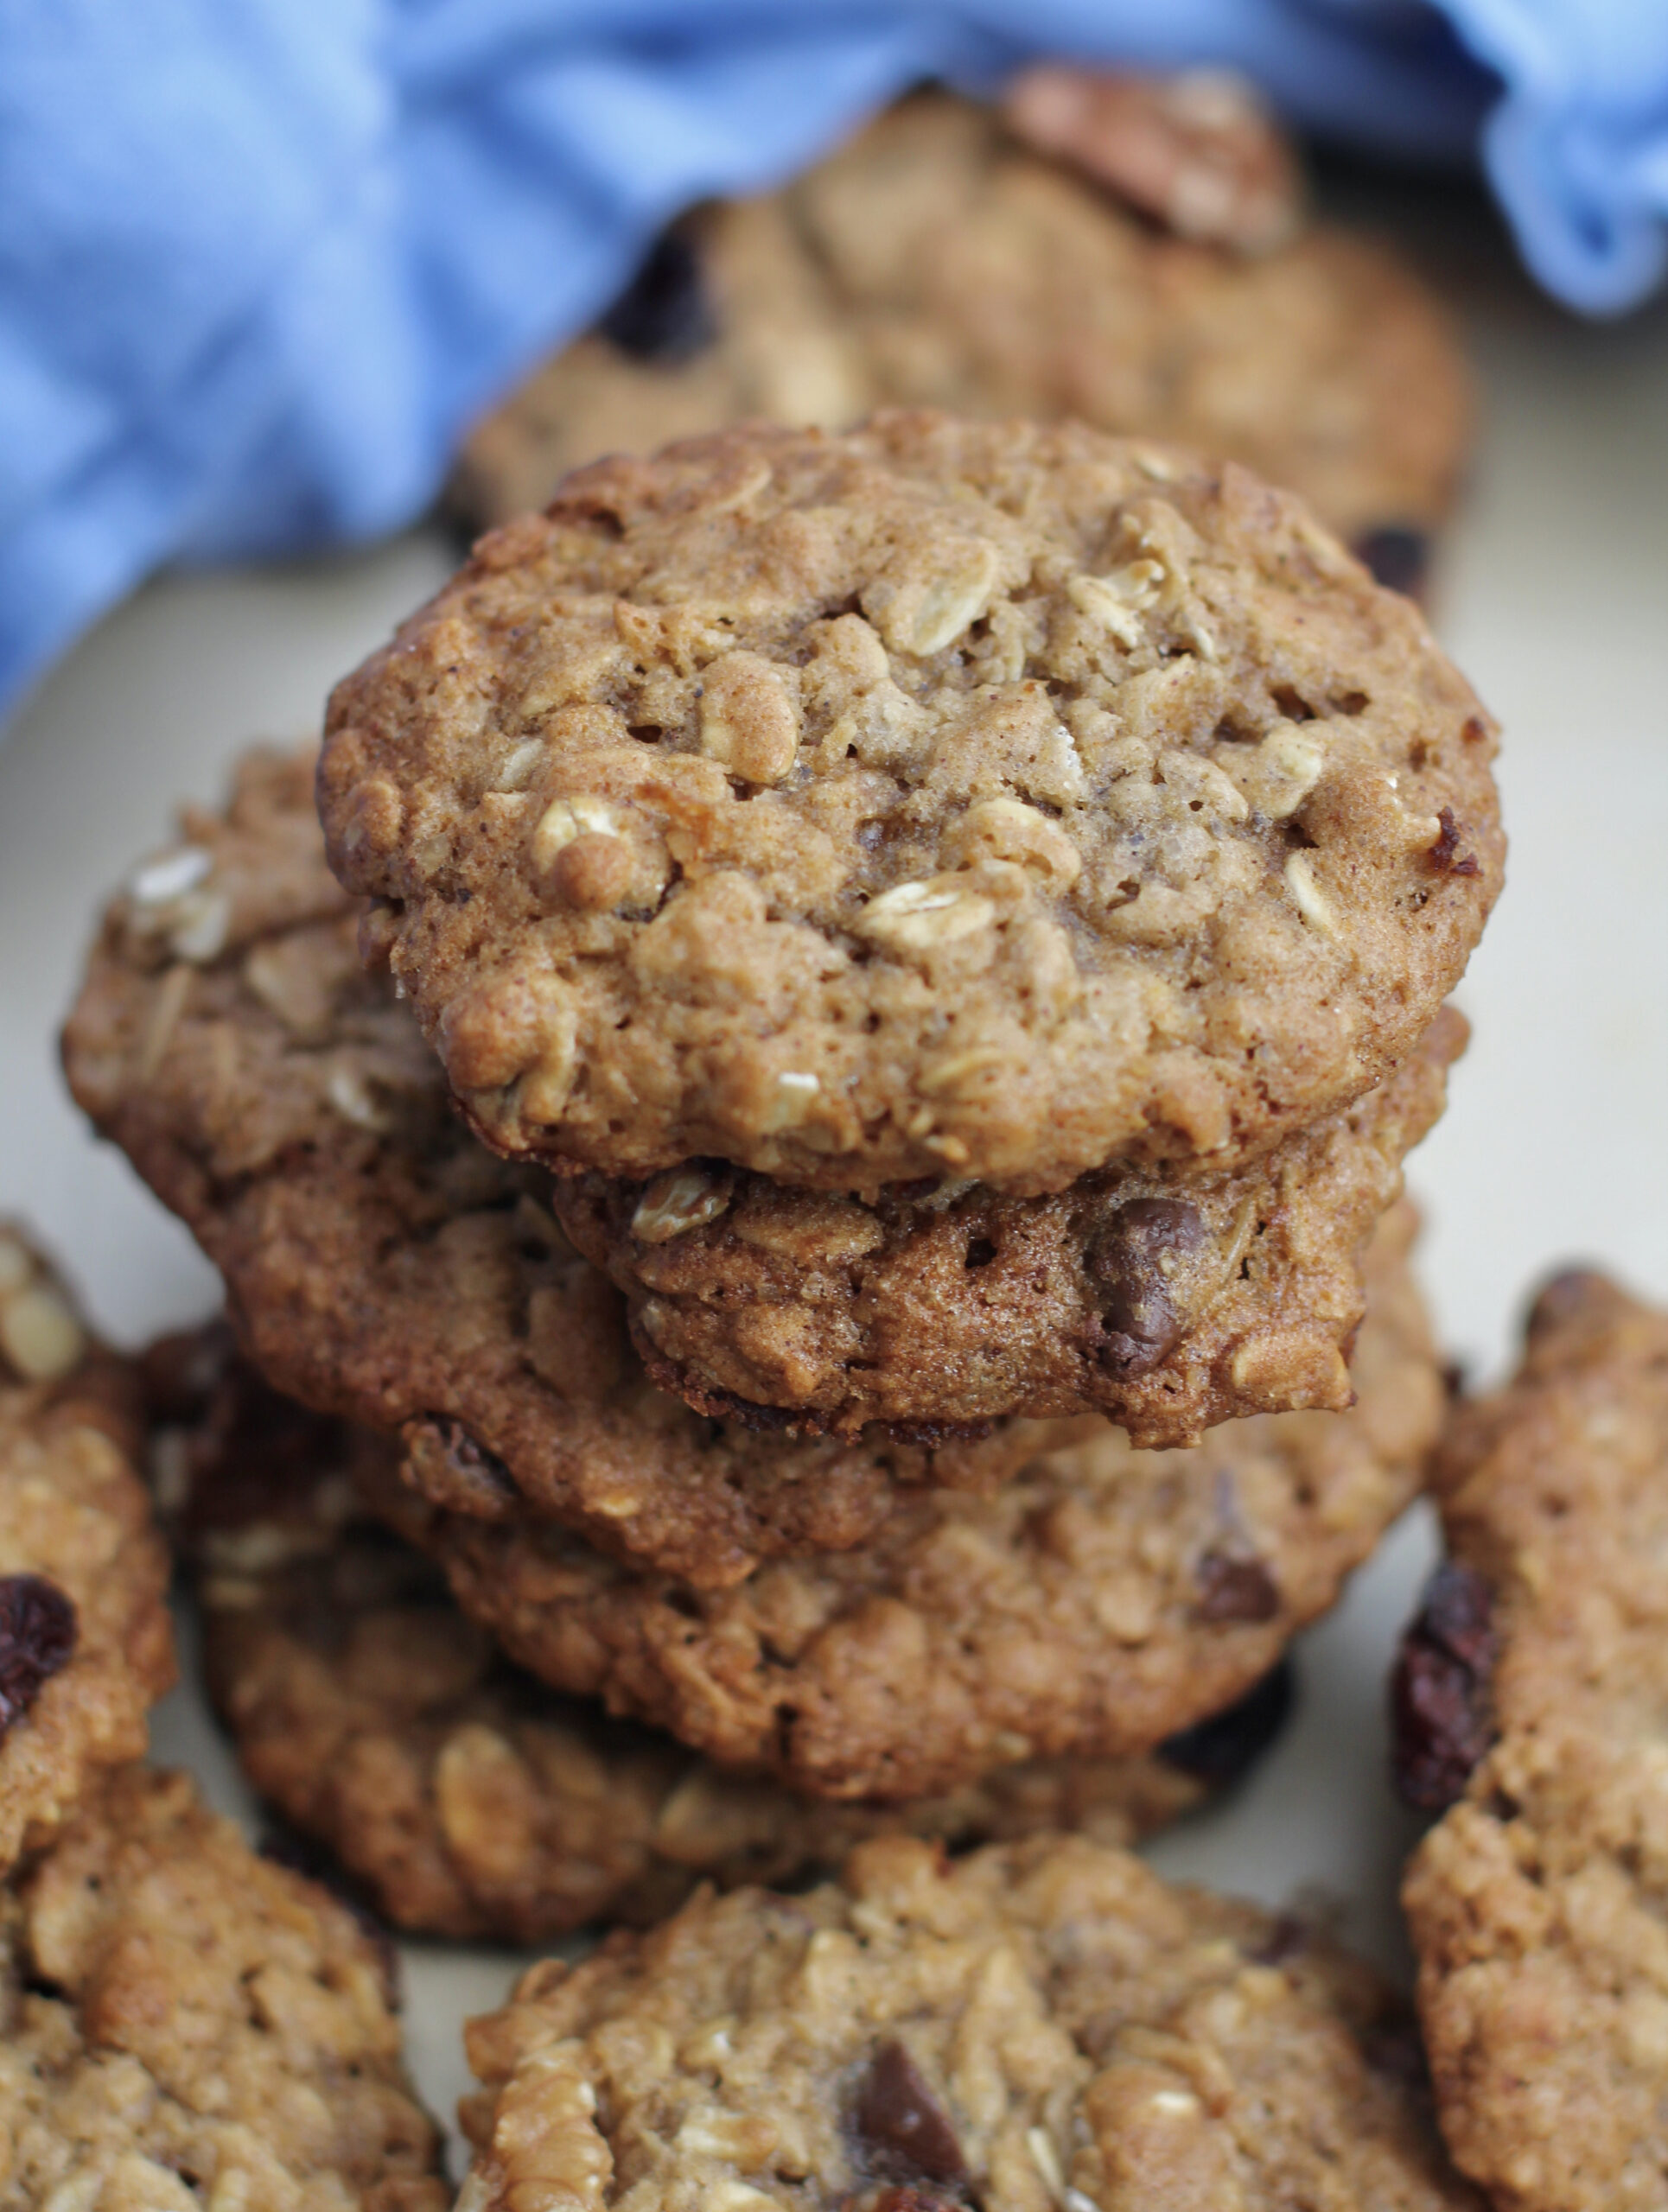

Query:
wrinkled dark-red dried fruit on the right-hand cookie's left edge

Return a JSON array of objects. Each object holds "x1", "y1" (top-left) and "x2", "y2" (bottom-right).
[{"x1": 1389, "y1": 1561, "x2": 1498, "y2": 1812}]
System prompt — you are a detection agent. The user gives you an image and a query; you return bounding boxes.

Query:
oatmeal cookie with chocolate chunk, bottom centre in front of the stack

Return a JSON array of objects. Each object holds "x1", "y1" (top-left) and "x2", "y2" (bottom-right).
[{"x1": 460, "y1": 1836, "x2": 1478, "y2": 2212}]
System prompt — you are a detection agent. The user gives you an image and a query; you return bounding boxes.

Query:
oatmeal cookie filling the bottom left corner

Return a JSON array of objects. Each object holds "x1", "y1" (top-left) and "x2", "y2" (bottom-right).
[{"x1": 0, "y1": 1767, "x2": 451, "y2": 2212}]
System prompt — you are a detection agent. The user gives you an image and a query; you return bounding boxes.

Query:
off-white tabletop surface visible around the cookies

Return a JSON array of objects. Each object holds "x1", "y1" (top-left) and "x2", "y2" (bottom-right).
[{"x1": 0, "y1": 267, "x2": 1668, "y2": 2167}]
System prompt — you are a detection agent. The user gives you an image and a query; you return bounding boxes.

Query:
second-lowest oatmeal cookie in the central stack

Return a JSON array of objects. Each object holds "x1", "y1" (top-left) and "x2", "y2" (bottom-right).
[{"x1": 379, "y1": 1208, "x2": 1442, "y2": 1798}]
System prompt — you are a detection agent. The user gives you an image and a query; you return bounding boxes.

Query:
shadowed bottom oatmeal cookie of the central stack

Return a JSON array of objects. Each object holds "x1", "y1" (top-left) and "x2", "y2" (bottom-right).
[{"x1": 157, "y1": 1340, "x2": 1289, "y2": 1942}]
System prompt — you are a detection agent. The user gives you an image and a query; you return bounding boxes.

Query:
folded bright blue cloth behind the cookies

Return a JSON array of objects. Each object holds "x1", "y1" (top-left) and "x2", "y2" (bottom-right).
[{"x1": 0, "y1": 0, "x2": 1668, "y2": 710}]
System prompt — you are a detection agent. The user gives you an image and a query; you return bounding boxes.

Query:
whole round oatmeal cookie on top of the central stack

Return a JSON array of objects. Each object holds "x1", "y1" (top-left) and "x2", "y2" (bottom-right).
[{"x1": 319, "y1": 416, "x2": 1502, "y2": 1192}]
